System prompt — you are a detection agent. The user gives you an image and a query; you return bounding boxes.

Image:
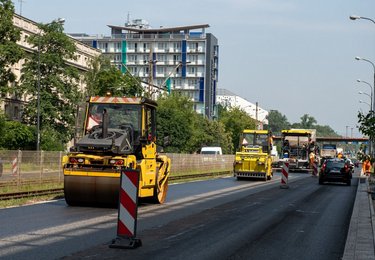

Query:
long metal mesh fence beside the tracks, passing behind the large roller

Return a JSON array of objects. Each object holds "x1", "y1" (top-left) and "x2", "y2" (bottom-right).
[{"x1": 0, "y1": 150, "x2": 234, "y2": 187}]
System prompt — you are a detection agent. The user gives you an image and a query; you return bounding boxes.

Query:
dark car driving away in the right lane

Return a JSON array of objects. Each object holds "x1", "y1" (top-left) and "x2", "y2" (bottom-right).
[{"x1": 319, "y1": 159, "x2": 353, "y2": 186}]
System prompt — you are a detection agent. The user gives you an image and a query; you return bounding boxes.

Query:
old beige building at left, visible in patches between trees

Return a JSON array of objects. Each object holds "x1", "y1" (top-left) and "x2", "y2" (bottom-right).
[{"x1": 7, "y1": 14, "x2": 101, "y2": 120}]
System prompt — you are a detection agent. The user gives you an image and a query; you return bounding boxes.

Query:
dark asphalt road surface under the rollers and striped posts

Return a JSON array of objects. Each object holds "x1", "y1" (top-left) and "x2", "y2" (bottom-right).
[{"x1": 0, "y1": 173, "x2": 357, "y2": 259}]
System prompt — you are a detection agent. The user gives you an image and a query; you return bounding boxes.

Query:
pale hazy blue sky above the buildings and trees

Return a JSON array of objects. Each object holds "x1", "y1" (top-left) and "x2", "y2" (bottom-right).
[{"x1": 13, "y1": 0, "x2": 375, "y2": 136}]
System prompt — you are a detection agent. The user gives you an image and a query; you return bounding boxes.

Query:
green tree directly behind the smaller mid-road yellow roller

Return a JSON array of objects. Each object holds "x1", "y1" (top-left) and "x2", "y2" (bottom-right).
[{"x1": 219, "y1": 107, "x2": 255, "y2": 151}]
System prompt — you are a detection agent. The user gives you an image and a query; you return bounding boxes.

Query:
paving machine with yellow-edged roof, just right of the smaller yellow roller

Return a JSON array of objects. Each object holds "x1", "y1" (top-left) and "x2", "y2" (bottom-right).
[{"x1": 279, "y1": 129, "x2": 317, "y2": 170}]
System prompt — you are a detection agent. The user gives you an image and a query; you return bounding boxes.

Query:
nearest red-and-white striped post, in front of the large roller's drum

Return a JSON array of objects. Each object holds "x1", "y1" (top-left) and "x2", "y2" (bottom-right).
[{"x1": 109, "y1": 170, "x2": 142, "y2": 248}]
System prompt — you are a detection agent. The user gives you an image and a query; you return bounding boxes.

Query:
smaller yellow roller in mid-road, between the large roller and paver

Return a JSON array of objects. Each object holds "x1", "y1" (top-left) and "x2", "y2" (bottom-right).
[{"x1": 233, "y1": 130, "x2": 273, "y2": 181}]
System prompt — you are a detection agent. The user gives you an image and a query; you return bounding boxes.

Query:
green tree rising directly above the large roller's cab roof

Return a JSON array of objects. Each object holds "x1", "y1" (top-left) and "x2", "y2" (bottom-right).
[{"x1": 85, "y1": 56, "x2": 143, "y2": 97}]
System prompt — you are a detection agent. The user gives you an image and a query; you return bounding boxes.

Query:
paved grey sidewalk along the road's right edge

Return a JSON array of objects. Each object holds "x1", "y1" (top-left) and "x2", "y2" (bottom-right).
[{"x1": 342, "y1": 177, "x2": 375, "y2": 260}]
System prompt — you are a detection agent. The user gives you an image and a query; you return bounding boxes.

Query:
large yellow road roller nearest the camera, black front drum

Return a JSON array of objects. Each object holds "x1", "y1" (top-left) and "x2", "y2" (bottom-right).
[{"x1": 63, "y1": 96, "x2": 171, "y2": 206}]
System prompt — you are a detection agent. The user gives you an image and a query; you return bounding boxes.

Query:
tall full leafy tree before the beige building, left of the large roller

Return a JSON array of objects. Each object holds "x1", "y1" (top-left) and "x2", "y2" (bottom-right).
[{"x1": 19, "y1": 21, "x2": 82, "y2": 147}]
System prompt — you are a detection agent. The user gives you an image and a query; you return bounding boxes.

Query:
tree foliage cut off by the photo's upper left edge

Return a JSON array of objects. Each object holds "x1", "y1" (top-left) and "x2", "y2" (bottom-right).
[{"x1": 0, "y1": 0, "x2": 23, "y2": 95}]
